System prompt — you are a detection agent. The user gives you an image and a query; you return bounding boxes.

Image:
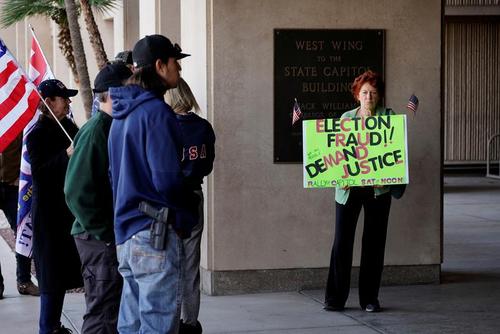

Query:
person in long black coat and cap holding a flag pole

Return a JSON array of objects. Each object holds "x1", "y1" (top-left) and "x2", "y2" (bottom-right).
[{"x1": 27, "y1": 79, "x2": 83, "y2": 334}]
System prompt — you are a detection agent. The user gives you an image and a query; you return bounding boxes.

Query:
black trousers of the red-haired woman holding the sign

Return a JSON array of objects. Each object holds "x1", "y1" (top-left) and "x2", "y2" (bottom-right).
[{"x1": 325, "y1": 187, "x2": 391, "y2": 308}]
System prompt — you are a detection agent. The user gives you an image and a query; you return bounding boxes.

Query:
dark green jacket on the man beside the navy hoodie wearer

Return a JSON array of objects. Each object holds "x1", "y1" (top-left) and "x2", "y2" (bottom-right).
[{"x1": 64, "y1": 111, "x2": 114, "y2": 242}]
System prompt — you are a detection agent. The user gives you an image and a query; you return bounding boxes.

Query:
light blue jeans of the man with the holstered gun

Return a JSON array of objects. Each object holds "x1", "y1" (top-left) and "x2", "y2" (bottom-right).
[{"x1": 117, "y1": 225, "x2": 183, "y2": 334}]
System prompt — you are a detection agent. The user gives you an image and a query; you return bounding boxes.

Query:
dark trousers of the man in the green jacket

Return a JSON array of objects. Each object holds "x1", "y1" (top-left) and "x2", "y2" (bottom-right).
[{"x1": 75, "y1": 233, "x2": 123, "y2": 334}]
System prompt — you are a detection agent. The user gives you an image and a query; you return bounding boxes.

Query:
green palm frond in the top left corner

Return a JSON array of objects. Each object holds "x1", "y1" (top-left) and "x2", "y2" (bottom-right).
[{"x1": 0, "y1": 0, "x2": 54, "y2": 28}]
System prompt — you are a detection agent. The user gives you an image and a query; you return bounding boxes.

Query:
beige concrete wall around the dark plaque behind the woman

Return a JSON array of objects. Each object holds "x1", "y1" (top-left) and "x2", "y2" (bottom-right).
[{"x1": 181, "y1": 0, "x2": 442, "y2": 294}]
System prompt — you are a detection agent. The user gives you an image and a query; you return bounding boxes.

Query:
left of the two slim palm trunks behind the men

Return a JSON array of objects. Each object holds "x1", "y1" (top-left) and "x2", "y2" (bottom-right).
[{"x1": 64, "y1": 0, "x2": 93, "y2": 119}]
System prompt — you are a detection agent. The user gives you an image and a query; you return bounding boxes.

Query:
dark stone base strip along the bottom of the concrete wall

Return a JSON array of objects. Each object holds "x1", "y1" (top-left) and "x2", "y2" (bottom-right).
[{"x1": 201, "y1": 264, "x2": 441, "y2": 296}]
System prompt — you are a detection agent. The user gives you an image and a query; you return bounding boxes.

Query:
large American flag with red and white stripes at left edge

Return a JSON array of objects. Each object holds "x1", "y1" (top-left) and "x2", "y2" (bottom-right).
[{"x1": 0, "y1": 39, "x2": 40, "y2": 152}]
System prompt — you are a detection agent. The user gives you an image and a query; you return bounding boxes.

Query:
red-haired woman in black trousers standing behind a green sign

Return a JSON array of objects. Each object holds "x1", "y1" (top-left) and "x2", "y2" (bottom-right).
[{"x1": 325, "y1": 70, "x2": 394, "y2": 312}]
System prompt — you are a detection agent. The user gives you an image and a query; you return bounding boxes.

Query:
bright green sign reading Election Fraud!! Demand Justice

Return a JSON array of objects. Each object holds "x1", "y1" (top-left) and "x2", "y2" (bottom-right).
[{"x1": 302, "y1": 115, "x2": 409, "y2": 188}]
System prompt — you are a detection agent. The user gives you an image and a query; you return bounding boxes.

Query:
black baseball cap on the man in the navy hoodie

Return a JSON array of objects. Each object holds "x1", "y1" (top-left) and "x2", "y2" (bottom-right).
[{"x1": 132, "y1": 35, "x2": 190, "y2": 68}]
